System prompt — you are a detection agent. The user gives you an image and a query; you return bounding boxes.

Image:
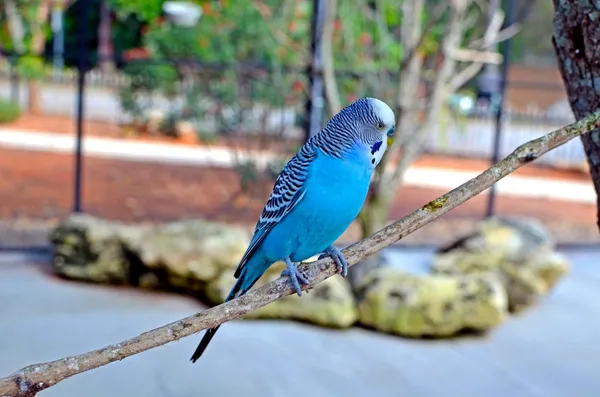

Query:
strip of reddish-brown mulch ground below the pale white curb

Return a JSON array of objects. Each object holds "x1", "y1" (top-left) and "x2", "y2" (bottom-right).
[{"x1": 0, "y1": 149, "x2": 595, "y2": 223}]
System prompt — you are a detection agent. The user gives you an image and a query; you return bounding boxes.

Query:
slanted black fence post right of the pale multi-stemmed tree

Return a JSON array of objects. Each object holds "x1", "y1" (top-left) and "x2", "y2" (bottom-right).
[{"x1": 485, "y1": 0, "x2": 515, "y2": 218}]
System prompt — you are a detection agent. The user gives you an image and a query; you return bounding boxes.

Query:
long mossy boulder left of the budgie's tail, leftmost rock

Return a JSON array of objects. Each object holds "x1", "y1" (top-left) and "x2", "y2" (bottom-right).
[{"x1": 50, "y1": 215, "x2": 250, "y2": 292}]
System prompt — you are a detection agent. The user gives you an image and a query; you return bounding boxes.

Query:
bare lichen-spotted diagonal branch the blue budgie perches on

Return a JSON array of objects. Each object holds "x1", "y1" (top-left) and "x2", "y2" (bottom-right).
[{"x1": 0, "y1": 112, "x2": 600, "y2": 397}]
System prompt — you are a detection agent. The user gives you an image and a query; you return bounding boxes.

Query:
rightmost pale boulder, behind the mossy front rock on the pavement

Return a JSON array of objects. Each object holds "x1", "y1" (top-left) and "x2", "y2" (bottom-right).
[{"x1": 432, "y1": 218, "x2": 569, "y2": 312}]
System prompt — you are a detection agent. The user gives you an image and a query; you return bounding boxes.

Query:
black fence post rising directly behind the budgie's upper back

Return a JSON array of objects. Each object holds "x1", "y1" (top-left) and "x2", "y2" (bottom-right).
[{"x1": 304, "y1": 0, "x2": 327, "y2": 141}]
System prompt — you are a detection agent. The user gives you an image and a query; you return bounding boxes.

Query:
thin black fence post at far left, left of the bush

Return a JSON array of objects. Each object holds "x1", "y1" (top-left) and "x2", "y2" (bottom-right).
[{"x1": 73, "y1": 0, "x2": 91, "y2": 213}]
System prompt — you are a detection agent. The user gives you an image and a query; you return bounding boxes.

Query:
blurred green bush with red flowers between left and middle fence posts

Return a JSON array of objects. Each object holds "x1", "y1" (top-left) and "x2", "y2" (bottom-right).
[{"x1": 120, "y1": 0, "x2": 310, "y2": 131}]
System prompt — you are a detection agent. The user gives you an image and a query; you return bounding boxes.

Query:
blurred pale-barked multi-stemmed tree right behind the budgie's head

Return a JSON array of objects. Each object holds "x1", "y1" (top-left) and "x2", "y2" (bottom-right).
[{"x1": 314, "y1": 0, "x2": 518, "y2": 279}]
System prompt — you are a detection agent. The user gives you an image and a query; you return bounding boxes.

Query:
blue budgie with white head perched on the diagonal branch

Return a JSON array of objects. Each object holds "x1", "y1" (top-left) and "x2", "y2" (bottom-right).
[{"x1": 191, "y1": 98, "x2": 395, "y2": 362}]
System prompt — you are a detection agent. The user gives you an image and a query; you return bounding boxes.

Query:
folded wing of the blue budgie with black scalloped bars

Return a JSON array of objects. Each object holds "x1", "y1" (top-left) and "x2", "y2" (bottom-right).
[{"x1": 234, "y1": 145, "x2": 315, "y2": 278}]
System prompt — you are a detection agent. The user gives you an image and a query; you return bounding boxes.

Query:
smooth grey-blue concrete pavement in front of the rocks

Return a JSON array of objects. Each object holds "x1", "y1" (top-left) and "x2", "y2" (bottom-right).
[{"x1": 0, "y1": 250, "x2": 600, "y2": 397}]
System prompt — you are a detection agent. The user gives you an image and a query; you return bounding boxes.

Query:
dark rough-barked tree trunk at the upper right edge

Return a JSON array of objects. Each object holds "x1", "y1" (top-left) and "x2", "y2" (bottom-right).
[{"x1": 552, "y1": 0, "x2": 600, "y2": 227}]
